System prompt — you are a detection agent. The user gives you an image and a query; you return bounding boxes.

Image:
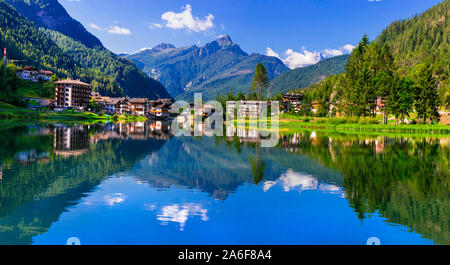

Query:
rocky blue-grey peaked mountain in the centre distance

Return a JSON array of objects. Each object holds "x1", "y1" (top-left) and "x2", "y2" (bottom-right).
[{"x1": 126, "y1": 35, "x2": 289, "y2": 101}]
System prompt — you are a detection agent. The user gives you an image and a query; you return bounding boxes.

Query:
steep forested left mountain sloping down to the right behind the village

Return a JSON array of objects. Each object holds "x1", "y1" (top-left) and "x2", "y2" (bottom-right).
[{"x1": 0, "y1": 0, "x2": 170, "y2": 99}]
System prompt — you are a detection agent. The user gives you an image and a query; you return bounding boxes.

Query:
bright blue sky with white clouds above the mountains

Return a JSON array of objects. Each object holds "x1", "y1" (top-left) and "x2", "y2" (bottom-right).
[{"x1": 59, "y1": 0, "x2": 441, "y2": 68}]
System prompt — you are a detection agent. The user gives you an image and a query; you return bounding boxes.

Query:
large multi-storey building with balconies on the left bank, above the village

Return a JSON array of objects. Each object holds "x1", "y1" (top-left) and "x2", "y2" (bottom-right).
[{"x1": 55, "y1": 79, "x2": 91, "y2": 110}]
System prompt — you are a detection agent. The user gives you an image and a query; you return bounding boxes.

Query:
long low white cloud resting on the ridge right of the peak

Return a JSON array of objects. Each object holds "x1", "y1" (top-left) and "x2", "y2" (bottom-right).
[{"x1": 266, "y1": 44, "x2": 354, "y2": 69}]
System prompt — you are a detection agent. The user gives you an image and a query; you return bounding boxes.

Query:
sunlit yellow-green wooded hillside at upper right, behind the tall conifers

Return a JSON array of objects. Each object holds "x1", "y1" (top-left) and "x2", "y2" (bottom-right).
[{"x1": 377, "y1": 0, "x2": 450, "y2": 104}]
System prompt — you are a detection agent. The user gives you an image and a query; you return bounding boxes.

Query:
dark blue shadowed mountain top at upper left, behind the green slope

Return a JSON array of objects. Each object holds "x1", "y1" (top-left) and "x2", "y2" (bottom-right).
[{"x1": 6, "y1": 0, "x2": 103, "y2": 48}]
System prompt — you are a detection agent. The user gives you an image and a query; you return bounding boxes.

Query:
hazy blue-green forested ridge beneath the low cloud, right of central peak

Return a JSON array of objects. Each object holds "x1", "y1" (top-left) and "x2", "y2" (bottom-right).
[{"x1": 271, "y1": 54, "x2": 349, "y2": 95}]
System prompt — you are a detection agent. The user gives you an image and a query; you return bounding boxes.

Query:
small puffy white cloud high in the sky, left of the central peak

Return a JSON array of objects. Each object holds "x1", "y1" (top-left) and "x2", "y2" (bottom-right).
[{"x1": 161, "y1": 4, "x2": 214, "y2": 32}]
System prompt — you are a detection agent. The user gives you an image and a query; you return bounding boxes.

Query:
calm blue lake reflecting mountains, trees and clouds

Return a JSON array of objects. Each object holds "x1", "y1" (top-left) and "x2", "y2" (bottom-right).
[{"x1": 0, "y1": 122, "x2": 450, "y2": 245}]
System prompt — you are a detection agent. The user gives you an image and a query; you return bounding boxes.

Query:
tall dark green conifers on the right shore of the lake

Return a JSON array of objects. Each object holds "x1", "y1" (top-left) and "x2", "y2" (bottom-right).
[{"x1": 302, "y1": 35, "x2": 444, "y2": 123}]
